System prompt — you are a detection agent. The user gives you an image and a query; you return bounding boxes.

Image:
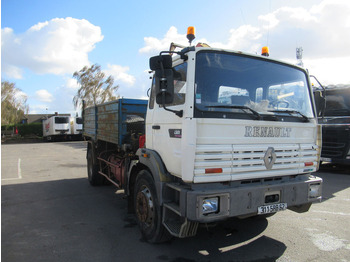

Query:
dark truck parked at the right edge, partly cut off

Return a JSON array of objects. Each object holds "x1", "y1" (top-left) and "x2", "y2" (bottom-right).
[{"x1": 314, "y1": 85, "x2": 350, "y2": 165}]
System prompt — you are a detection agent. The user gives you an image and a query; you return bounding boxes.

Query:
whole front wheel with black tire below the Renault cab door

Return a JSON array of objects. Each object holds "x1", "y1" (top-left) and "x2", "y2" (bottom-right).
[{"x1": 134, "y1": 170, "x2": 172, "y2": 243}]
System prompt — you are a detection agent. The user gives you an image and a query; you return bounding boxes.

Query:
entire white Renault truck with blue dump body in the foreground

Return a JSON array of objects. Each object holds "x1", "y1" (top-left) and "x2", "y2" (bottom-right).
[{"x1": 83, "y1": 29, "x2": 322, "y2": 243}]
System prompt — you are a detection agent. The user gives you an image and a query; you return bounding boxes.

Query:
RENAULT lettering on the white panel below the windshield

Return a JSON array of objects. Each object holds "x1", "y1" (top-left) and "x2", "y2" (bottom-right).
[{"x1": 244, "y1": 126, "x2": 292, "y2": 137}]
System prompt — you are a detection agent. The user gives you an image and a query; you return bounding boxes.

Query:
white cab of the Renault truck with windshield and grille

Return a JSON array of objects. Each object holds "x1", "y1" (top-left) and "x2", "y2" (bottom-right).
[{"x1": 146, "y1": 47, "x2": 320, "y2": 183}]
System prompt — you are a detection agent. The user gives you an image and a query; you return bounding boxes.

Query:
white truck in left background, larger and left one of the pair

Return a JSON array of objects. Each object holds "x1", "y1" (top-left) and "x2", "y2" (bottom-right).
[{"x1": 43, "y1": 115, "x2": 71, "y2": 141}]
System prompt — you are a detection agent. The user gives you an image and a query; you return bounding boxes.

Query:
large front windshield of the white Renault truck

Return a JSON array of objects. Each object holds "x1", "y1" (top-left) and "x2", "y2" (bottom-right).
[{"x1": 195, "y1": 51, "x2": 313, "y2": 121}]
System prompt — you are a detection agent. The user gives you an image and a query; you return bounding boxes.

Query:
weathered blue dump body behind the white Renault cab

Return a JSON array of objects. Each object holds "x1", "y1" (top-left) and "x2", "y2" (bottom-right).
[{"x1": 83, "y1": 99, "x2": 147, "y2": 146}]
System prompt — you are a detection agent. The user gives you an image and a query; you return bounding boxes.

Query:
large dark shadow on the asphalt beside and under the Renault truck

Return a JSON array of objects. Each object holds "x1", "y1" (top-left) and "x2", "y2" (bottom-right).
[{"x1": 1, "y1": 178, "x2": 286, "y2": 262}]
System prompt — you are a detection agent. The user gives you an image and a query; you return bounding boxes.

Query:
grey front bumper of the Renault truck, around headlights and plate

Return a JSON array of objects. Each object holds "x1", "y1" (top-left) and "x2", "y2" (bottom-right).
[{"x1": 180, "y1": 175, "x2": 322, "y2": 223}]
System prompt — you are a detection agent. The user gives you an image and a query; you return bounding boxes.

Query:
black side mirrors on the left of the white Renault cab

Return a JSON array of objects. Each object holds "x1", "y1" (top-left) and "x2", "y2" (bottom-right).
[{"x1": 149, "y1": 55, "x2": 174, "y2": 106}]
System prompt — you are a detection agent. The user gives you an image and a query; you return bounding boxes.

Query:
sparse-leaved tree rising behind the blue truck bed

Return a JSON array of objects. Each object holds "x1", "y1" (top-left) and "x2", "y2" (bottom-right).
[{"x1": 73, "y1": 64, "x2": 119, "y2": 108}]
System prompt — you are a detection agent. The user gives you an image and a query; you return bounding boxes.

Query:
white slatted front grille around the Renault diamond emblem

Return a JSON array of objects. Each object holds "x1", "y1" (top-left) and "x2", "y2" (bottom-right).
[{"x1": 194, "y1": 144, "x2": 317, "y2": 182}]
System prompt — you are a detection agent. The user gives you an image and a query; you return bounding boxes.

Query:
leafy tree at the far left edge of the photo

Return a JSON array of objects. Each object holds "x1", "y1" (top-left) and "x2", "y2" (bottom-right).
[{"x1": 1, "y1": 81, "x2": 29, "y2": 125}]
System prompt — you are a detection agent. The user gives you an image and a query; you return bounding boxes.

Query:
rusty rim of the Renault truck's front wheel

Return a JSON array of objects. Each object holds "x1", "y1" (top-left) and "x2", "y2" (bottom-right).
[{"x1": 136, "y1": 186, "x2": 154, "y2": 226}]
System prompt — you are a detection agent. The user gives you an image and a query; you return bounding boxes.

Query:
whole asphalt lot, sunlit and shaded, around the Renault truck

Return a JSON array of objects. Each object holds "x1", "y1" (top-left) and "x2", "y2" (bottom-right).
[{"x1": 1, "y1": 142, "x2": 350, "y2": 262}]
